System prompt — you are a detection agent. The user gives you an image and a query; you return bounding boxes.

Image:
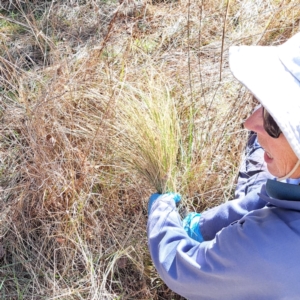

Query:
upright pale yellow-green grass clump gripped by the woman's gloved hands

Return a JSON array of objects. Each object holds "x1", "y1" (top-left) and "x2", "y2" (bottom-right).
[{"x1": 114, "y1": 74, "x2": 181, "y2": 193}]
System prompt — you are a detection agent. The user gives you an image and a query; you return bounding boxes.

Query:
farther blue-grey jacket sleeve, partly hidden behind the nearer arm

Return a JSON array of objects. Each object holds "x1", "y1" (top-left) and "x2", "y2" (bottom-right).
[{"x1": 199, "y1": 187, "x2": 266, "y2": 241}]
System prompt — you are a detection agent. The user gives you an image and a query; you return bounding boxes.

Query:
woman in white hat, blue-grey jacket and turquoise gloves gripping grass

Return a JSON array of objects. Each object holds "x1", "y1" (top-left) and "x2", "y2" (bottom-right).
[{"x1": 147, "y1": 33, "x2": 300, "y2": 300}]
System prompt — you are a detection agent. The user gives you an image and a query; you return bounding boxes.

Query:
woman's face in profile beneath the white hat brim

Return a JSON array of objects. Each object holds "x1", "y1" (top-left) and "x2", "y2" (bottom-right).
[{"x1": 244, "y1": 107, "x2": 300, "y2": 178}]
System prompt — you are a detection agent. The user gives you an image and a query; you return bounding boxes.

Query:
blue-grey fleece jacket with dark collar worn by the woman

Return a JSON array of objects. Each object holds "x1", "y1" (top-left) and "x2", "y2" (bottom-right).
[{"x1": 147, "y1": 180, "x2": 300, "y2": 300}]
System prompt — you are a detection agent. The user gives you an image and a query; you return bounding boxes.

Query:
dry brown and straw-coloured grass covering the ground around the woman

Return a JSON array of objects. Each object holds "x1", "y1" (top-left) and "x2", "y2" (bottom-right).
[{"x1": 0, "y1": 0, "x2": 300, "y2": 299}]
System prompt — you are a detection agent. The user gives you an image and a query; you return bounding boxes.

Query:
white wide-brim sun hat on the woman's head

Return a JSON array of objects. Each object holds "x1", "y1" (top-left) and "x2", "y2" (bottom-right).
[{"x1": 229, "y1": 33, "x2": 300, "y2": 159}]
